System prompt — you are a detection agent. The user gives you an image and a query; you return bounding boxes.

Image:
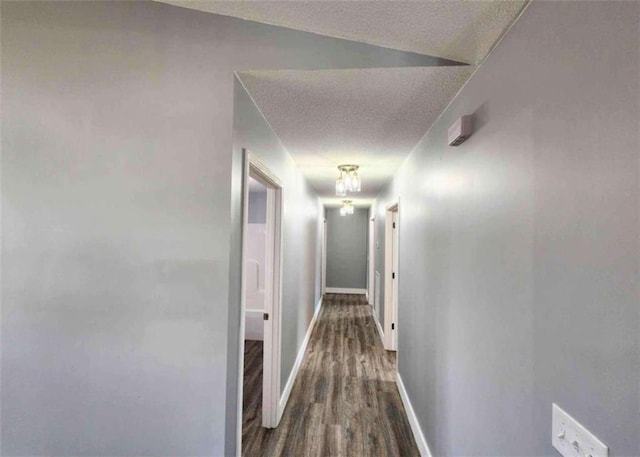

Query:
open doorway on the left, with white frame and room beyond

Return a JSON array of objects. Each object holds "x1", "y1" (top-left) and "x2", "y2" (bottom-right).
[{"x1": 239, "y1": 151, "x2": 282, "y2": 455}]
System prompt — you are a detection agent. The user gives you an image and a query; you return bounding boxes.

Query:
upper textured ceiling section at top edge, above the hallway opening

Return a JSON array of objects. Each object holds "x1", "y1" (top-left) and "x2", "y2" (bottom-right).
[{"x1": 161, "y1": 0, "x2": 527, "y2": 64}]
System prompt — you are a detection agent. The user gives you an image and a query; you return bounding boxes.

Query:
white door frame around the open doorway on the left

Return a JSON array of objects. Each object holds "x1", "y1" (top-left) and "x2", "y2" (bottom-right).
[{"x1": 237, "y1": 149, "x2": 284, "y2": 455}]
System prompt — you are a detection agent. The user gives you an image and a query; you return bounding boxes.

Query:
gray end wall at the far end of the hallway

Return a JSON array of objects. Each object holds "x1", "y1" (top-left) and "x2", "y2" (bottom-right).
[{"x1": 327, "y1": 208, "x2": 369, "y2": 289}]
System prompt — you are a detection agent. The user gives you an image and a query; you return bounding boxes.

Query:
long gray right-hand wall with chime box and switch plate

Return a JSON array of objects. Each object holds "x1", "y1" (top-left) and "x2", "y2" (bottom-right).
[{"x1": 376, "y1": 2, "x2": 640, "y2": 456}]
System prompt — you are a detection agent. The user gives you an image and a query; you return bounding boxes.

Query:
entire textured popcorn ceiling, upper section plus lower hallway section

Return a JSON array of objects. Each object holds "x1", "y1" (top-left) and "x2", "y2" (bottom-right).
[{"x1": 159, "y1": 0, "x2": 527, "y2": 206}]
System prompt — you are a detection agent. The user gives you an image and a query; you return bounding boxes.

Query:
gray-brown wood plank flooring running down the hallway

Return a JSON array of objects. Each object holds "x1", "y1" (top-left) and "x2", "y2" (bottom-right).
[{"x1": 242, "y1": 294, "x2": 420, "y2": 457}]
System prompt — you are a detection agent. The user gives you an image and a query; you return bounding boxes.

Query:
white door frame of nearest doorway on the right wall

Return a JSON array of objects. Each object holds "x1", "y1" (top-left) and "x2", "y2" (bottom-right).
[{"x1": 384, "y1": 198, "x2": 400, "y2": 351}]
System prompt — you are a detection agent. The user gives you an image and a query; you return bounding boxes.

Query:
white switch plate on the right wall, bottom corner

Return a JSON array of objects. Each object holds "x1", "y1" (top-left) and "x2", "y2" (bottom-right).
[{"x1": 551, "y1": 403, "x2": 609, "y2": 457}]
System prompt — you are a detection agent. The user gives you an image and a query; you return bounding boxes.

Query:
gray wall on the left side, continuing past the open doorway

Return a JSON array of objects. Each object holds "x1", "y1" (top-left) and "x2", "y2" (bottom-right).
[{"x1": 0, "y1": 1, "x2": 450, "y2": 456}]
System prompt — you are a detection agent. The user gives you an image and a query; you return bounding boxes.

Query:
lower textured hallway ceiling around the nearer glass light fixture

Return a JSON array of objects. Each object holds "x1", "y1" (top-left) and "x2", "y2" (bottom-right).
[{"x1": 239, "y1": 66, "x2": 473, "y2": 202}]
